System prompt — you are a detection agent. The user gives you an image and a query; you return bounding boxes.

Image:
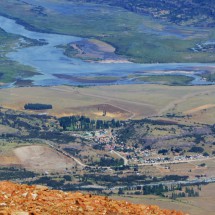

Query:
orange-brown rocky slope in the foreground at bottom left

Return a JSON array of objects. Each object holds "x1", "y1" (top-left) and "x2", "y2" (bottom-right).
[{"x1": 0, "y1": 182, "x2": 185, "y2": 215}]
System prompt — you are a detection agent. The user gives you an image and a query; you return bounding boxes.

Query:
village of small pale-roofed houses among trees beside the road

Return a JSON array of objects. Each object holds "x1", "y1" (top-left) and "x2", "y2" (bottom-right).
[{"x1": 74, "y1": 129, "x2": 213, "y2": 166}]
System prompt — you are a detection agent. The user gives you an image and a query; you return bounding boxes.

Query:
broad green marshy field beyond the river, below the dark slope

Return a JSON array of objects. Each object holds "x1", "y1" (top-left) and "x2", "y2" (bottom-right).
[{"x1": 0, "y1": 0, "x2": 214, "y2": 63}]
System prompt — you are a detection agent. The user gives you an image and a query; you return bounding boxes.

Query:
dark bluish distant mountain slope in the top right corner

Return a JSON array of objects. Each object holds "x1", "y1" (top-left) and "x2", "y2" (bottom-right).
[{"x1": 72, "y1": 0, "x2": 215, "y2": 27}]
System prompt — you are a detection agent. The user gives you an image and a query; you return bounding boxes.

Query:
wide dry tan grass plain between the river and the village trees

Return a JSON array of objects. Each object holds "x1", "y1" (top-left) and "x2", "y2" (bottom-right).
[{"x1": 0, "y1": 85, "x2": 215, "y2": 123}]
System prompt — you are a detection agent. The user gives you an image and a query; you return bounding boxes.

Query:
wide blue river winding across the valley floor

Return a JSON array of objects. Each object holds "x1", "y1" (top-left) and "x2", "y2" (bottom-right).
[{"x1": 0, "y1": 16, "x2": 215, "y2": 86}]
